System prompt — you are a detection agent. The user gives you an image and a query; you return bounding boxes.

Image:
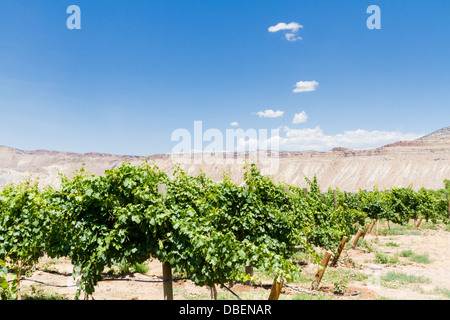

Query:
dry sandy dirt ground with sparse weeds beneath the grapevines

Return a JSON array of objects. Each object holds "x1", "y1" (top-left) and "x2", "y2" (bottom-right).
[{"x1": 14, "y1": 223, "x2": 450, "y2": 300}]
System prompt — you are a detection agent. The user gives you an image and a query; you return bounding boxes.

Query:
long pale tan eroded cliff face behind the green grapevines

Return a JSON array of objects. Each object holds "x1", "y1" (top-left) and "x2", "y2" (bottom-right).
[{"x1": 0, "y1": 128, "x2": 450, "y2": 192}]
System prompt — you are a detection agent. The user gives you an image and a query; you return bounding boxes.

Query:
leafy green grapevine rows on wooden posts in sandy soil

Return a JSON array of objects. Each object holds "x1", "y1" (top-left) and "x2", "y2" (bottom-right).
[{"x1": 0, "y1": 162, "x2": 450, "y2": 299}]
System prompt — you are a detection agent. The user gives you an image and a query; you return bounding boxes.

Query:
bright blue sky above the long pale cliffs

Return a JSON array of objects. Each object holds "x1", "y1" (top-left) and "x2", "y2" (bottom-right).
[{"x1": 0, "y1": 0, "x2": 450, "y2": 156}]
